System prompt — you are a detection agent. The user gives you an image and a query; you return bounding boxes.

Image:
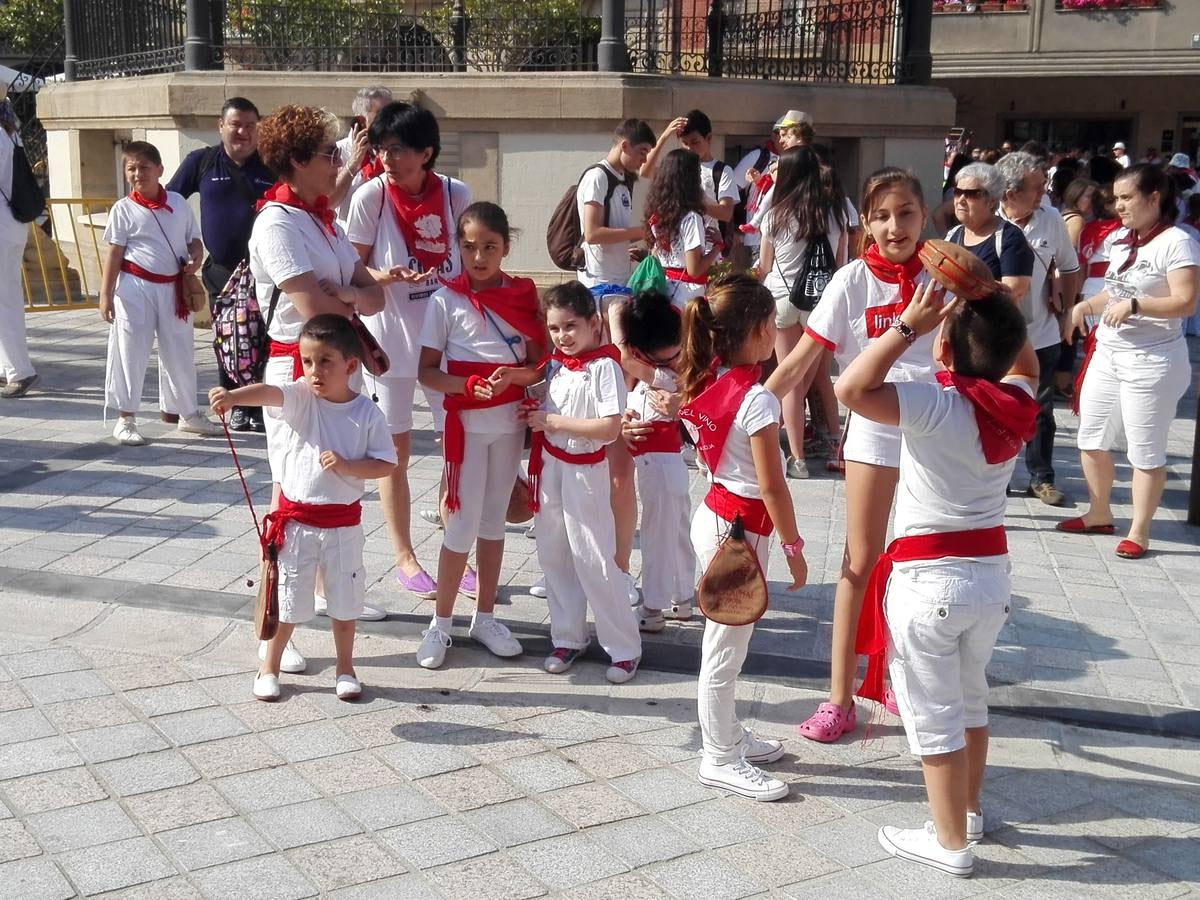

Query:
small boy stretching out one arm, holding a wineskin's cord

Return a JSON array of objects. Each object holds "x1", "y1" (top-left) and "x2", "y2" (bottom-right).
[{"x1": 209, "y1": 313, "x2": 396, "y2": 701}]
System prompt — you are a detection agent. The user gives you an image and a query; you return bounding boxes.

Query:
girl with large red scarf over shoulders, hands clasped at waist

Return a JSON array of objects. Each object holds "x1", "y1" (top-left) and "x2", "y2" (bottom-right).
[{"x1": 416, "y1": 203, "x2": 546, "y2": 668}]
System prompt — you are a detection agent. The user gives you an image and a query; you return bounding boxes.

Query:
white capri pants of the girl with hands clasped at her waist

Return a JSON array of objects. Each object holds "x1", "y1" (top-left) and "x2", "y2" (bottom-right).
[{"x1": 442, "y1": 428, "x2": 524, "y2": 553}]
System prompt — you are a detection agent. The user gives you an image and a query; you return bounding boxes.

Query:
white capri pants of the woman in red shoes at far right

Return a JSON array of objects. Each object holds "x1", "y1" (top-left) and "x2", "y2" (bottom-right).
[{"x1": 1078, "y1": 338, "x2": 1192, "y2": 469}]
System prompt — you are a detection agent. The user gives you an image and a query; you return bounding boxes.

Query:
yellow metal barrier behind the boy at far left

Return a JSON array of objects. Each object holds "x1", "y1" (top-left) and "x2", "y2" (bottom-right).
[{"x1": 20, "y1": 198, "x2": 116, "y2": 312}]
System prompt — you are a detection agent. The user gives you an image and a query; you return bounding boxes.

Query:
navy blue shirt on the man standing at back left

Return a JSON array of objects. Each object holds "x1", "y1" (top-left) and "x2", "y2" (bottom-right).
[{"x1": 167, "y1": 144, "x2": 275, "y2": 269}]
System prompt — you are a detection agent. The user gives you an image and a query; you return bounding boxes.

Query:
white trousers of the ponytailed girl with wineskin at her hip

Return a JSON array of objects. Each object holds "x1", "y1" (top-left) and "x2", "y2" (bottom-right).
[{"x1": 691, "y1": 504, "x2": 770, "y2": 766}]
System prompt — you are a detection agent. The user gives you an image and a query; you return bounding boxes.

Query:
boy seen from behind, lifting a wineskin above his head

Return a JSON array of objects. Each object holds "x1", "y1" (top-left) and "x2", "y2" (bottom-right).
[{"x1": 835, "y1": 284, "x2": 1038, "y2": 876}]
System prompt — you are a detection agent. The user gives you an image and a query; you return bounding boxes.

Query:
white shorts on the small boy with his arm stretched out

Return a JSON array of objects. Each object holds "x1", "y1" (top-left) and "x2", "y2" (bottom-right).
[{"x1": 280, "y1": 522, "x2": 367, "y2": 625}]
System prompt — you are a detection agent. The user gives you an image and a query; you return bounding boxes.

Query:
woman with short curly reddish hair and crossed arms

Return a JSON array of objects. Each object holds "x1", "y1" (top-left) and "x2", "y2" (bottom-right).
[{"x1": 250, "y1": 106, "x2": 385, "y2": 673}]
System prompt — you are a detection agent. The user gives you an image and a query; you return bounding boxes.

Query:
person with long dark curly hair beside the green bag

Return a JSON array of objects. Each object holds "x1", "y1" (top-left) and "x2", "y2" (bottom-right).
[{"x1": 646, "y1": 150, "x2": 721, "y2": 310}]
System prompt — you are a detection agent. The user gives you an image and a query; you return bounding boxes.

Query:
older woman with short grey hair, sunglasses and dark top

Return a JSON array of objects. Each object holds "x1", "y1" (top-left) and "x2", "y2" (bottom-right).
[{"x1": 946, "y1": 162, "x2": 1033, "y2": 298}]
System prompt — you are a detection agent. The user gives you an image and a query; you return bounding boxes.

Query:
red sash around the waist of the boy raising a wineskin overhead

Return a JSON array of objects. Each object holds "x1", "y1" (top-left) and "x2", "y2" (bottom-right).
[{"x1": 854, "y1": 526, "x2": 1008, "y2": 703}]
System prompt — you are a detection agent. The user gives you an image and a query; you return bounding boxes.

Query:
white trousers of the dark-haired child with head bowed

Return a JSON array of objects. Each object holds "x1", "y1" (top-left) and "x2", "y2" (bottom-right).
[{"x1": 634, "y1": 454, "x2": 696, "y2": 610}]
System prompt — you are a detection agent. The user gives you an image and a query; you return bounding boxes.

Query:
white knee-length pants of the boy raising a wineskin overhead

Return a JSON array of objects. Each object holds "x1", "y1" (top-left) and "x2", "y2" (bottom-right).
[{"x1": 883, "y1": 556, "x2": 1012, "y2": 756}]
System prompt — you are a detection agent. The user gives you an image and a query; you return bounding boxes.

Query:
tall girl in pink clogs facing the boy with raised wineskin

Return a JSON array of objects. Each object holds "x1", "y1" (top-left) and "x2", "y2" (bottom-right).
[{"x1": 767, "y1": 168, "x2": 935, "y2": 743}]
